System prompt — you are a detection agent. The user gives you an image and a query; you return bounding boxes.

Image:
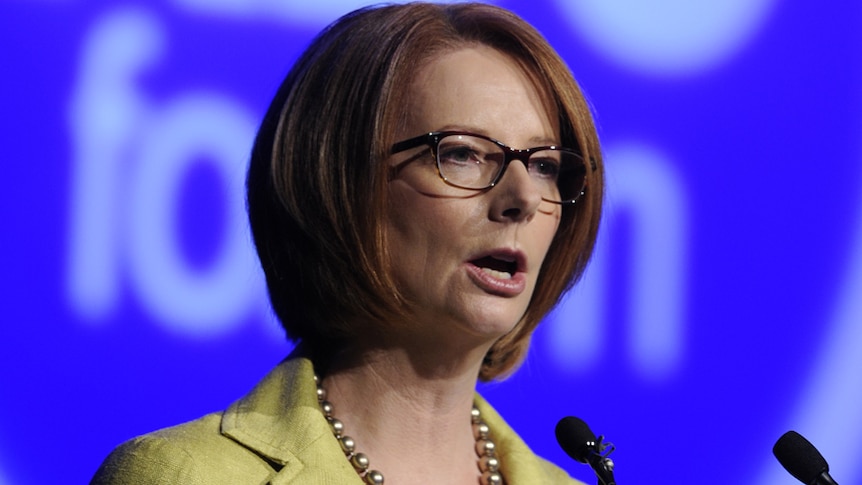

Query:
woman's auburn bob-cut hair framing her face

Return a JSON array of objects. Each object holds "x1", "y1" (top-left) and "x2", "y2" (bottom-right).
[{"x1": 247, "y1": 3, "x2": 603, "y2": 381}]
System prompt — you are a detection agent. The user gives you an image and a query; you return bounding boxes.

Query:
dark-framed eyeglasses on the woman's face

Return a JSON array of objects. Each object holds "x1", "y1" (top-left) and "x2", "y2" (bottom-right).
[{"x1": 392, "y1": 131, "x2": 596, "y2": 204}]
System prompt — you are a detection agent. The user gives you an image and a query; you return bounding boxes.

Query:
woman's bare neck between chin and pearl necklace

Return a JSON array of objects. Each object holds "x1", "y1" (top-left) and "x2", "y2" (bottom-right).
[{"x1": 322, "y1": 346, "x2": 496, "y2": 484}]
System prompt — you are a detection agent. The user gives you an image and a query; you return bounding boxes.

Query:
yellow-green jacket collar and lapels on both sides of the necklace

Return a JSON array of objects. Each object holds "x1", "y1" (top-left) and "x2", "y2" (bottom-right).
[{"x1": 221, "y1": 356, "x2": 580, "y2": 485}]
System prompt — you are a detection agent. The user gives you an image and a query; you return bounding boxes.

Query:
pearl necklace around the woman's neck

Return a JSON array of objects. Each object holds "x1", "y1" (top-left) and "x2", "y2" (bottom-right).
[{"x1": 314, "y1": 374, "x2": 503, "y2": 485}]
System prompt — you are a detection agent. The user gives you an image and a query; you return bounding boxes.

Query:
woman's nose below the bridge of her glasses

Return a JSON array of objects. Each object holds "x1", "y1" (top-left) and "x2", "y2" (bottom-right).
[{"x1": 488, "y1": 158, "x2": 542, "y2": 222}]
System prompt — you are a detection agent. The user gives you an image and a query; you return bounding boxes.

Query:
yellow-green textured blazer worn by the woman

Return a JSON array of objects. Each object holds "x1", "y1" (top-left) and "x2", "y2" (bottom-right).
[{"x1": 90, "y1": 357, "x2": 581, "y2": 485}]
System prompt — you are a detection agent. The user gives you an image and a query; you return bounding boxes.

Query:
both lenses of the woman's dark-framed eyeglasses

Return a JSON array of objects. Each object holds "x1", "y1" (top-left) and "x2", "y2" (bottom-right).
[{"x1": 437, "y1": 135, "x2": 586, "y2": 202}]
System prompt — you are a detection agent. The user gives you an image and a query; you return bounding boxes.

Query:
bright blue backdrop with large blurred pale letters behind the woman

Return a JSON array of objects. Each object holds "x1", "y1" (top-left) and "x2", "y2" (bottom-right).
[{"x1": 0, "y1": 0, "x2": 862, "y2": 485}]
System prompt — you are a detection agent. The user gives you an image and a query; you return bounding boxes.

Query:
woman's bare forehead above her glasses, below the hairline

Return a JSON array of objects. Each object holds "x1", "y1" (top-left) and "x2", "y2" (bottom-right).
[{"x1": 404, "y1": 45, "x2": 558, "y2": 140}]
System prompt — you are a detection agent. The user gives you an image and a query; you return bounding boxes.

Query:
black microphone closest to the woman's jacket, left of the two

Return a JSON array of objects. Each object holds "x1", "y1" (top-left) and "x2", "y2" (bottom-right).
[{"x1": 554, "y1": 416, "x2": 616, "y2": 485}]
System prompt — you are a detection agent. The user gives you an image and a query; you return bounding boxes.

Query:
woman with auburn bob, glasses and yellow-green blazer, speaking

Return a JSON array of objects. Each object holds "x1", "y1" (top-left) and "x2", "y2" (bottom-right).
[{"x1": 93, "y1": 3, "x2": 602, "y2": 485}]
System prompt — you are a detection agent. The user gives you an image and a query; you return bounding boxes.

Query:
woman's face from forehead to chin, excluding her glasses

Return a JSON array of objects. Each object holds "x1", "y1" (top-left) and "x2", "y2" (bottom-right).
[{"x1": 387, "y1": 46, "x2": 561, "y2": 343}]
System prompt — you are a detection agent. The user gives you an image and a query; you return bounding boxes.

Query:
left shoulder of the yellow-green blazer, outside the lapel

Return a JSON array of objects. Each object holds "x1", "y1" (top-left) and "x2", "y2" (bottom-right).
[{"x1": 90, "y1": 413, "x2": 271, "y2": 485}]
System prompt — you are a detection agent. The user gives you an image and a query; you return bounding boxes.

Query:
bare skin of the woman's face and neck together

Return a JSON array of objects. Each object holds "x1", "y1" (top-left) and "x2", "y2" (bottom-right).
[{"x1": 323, "y1": 45, "x2": 561, "y2": 484}]
